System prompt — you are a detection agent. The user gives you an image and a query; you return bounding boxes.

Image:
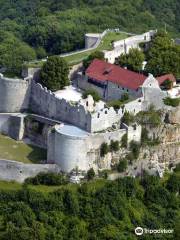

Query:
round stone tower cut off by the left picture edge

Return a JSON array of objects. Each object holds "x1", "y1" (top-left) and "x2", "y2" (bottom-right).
[{"x1": 0, "y1": 74, "x2": 30, "y2": 113}]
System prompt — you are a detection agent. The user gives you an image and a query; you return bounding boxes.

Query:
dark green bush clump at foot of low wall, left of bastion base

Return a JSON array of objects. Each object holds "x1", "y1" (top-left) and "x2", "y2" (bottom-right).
[{"x1": 25, "y1": 173, "x2": 67, "y2": 186}]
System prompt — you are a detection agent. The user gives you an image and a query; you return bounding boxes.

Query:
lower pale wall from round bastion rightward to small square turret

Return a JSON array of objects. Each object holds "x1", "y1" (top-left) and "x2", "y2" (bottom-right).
[{"x1": 47, "y1": 124, "x2": 141, "y2": 172}]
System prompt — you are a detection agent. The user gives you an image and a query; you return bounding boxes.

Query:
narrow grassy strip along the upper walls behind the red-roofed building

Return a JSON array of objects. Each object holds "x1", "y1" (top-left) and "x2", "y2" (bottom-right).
[{"x1": 28, "y1": 32, "x2": 128, "y2": 67}]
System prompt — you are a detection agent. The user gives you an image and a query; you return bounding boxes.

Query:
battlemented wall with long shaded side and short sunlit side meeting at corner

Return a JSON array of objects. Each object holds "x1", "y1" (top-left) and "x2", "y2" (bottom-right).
[{"x1": 30, "y1": 81, "x2": 120, "y2": 132}]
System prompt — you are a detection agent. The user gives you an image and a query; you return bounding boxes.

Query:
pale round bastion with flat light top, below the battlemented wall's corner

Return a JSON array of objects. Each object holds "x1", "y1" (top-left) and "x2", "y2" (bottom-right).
[{"x1": 54, "y1": 124, "x2": 89, "y2": 172}]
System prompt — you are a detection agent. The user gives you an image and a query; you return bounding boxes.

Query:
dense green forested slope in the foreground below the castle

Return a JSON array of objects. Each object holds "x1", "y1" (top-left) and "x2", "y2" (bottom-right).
[{"x1": 0, "y1": 172, "x2": 180, "y2": 240}]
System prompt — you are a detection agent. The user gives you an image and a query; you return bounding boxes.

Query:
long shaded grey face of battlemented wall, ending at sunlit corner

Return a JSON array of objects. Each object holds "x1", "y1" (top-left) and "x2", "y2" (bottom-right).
[{"x1": 30, "y1": 82, "x2": 91, "y2": 131}]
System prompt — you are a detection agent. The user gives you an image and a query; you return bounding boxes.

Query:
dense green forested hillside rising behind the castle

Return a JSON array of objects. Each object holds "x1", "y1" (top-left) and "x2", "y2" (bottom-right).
[{"x1": 0, "y1": 0, "x2": 180, "y2": 57}]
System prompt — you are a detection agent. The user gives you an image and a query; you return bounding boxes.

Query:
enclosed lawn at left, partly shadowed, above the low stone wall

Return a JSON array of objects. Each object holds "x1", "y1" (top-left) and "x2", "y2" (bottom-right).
[{"x1": 0, "y1": 135, "x2": 46, "y2": 163}]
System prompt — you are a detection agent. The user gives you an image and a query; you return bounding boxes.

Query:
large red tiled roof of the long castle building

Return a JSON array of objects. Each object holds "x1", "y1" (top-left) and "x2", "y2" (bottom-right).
[{"x1": 86, "y1": 59, "x2": 147, "y2": 90}]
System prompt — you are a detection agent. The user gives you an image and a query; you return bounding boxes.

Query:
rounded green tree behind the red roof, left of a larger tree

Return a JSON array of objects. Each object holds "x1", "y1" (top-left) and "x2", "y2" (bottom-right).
[{"x1": 119, "y1": 48, "x2": 145, "y2": 72}]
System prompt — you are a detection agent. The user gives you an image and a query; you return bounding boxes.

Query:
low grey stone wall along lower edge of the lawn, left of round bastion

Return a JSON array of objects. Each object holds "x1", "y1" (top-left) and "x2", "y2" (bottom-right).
[{"x1": 0, "y1": 160, "x2": 61, "y2": 182}]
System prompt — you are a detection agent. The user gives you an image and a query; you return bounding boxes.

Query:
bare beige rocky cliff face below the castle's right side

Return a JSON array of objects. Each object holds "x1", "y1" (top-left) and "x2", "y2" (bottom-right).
[{"x1": 96, "y1": 107, "x2": 180, "y2": 175}]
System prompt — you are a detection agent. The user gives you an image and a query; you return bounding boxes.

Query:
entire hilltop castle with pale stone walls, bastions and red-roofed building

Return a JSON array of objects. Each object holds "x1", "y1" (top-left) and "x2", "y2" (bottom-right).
[{"x1": 0, "y1": 28, "x2": 180, "y2": 172}]
